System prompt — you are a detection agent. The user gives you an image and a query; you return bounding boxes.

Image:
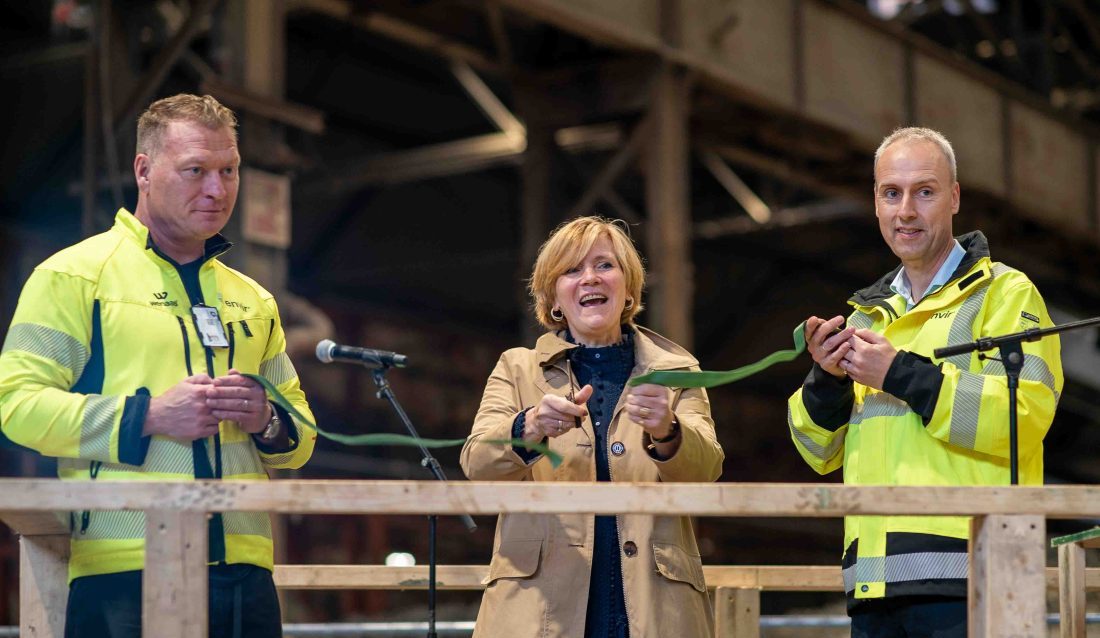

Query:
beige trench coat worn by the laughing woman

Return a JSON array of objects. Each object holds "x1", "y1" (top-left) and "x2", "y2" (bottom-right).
[{"x1": 462, "y1": 328, "x2": 724, "y2": 638}]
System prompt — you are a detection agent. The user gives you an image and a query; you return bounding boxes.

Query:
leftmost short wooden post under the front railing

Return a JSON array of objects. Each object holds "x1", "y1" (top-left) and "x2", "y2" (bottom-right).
[{"x1": 19, "y1": 534, "x2": 69, "y2": 638}]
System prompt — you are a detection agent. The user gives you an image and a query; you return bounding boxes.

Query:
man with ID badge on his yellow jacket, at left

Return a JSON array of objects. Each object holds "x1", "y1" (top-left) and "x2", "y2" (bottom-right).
[{"x1": 0, "y1": 95, "x2": 315, "y2": 638}]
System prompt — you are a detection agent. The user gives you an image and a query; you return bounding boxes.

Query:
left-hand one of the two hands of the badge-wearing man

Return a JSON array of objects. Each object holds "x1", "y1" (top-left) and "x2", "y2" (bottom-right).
[{"x1": 142, "y1": 374, "x2": 220, "y2": 442}]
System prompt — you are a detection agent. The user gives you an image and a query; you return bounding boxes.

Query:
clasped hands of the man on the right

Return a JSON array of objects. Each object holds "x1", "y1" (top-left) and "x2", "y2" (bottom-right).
[{"x1": 805, "y1": 315, "x2": 898, "y2": 389}]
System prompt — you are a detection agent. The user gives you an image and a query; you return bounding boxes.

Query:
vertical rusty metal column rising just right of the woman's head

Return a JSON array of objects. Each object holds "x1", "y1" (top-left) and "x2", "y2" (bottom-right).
[{"x1": 646, "y1": 65, "x2": 694, "y2": 350}]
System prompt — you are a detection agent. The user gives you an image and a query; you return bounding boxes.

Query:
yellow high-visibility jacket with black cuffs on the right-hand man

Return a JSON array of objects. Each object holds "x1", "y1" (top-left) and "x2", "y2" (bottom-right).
[{"x1": 788, "y1": 232, "x2": 1063, "y2": 607}]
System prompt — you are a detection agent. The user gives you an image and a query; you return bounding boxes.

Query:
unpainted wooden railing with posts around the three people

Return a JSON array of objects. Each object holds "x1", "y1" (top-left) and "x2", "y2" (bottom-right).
[{"x1": 0, "y1": 480, "x2": 1100, "y2": 638}]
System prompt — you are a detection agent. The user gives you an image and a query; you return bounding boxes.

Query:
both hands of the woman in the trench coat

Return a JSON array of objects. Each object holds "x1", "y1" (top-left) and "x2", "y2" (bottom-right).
[{"x1": 524, "y1": 383, "x2": 673, "y2": 442}]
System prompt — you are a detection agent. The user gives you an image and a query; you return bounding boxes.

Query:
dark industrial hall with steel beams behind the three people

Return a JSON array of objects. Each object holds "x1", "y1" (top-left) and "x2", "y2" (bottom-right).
[{"x1": 0, "y1": 0, "x2": 1100, "y2": 624}]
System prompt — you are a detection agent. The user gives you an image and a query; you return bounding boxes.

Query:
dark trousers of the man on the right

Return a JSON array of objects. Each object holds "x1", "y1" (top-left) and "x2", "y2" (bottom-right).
[{"x1": 850, "y1": 596, "x2": 967, "y2": 638}]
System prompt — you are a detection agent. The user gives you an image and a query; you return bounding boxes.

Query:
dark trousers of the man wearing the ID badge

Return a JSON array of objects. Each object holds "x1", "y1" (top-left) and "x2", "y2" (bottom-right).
[{"x1": 65, "y1": 564, "x2": 283, "y2": 638}]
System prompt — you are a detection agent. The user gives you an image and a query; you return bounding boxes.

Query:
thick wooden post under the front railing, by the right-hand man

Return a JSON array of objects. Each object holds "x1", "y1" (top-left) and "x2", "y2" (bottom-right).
[{"x1": 968, "y1": 515, "x2": 1047, "y2": 638}]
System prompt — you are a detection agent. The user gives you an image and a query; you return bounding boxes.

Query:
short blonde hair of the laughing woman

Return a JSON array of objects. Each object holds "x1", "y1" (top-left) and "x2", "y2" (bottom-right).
[{"x1": 527, "y1": 217, "x2": 646, "y2": 330}]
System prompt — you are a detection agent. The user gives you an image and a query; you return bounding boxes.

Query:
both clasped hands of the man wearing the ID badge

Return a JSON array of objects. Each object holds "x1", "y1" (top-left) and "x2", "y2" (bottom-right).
[{"x1": 142, "y1": 370, "x2": 272, "y2": 441}]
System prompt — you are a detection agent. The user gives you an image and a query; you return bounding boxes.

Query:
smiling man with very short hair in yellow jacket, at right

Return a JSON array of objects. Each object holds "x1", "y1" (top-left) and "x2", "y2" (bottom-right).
[{"x1": 788, "y1": 128, "x2": 1063, "y2": 638}]
